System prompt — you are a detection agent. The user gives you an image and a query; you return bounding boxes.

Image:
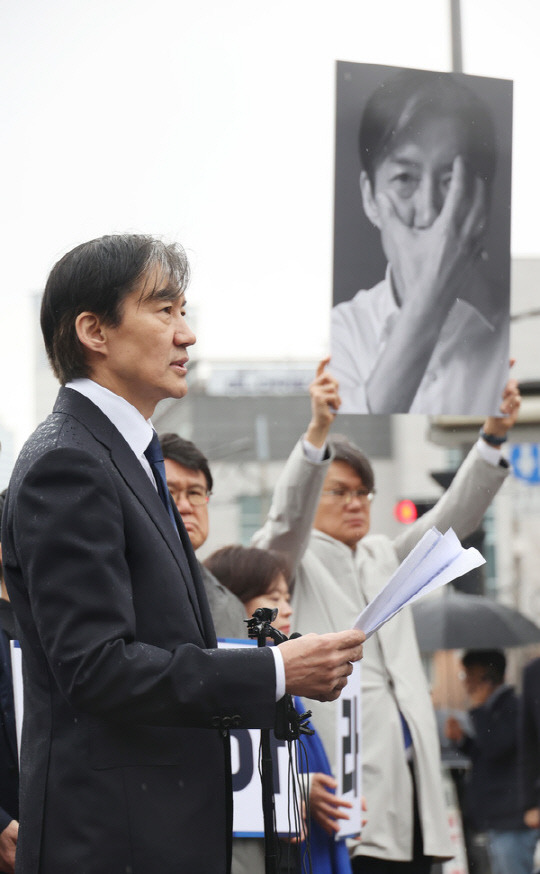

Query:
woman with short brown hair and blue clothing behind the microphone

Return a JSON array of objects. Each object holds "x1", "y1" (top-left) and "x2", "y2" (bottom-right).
[{"x1": 204, "y1": 546, "x2": 351, "y2": 874}]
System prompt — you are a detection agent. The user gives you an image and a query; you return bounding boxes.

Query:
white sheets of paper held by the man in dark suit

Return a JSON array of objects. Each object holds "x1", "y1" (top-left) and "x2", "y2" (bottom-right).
[{"x1": 354, "y1": 528, "x2": 485, "y2": 640}]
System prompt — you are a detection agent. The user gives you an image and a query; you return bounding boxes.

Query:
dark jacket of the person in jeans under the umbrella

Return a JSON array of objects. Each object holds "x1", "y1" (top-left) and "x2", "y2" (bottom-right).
[{"x1": 461, "y1": 686, "x2": 526, "y2": 832}]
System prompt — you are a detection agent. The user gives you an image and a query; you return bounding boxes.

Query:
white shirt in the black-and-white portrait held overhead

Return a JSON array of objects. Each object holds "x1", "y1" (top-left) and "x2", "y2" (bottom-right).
[{"x1": 330, "y1": 270, "x2": 509, "y2": 416}]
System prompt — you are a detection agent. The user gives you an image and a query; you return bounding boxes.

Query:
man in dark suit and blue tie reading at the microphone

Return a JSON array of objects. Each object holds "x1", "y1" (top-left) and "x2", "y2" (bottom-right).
[{"x1": 2, "y1": 235, "x2": 363, "y2": 874}]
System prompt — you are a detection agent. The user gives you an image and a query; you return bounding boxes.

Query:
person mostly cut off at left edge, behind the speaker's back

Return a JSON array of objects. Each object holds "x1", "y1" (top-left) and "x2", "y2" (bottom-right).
[{"x1": 0, "y1": 490, "x2": 19, "y2": 874}]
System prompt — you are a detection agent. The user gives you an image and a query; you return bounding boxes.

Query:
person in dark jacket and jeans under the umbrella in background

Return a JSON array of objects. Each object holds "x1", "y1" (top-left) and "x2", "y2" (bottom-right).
[{"x1": 445, "y1": 650, "x2": 538, "y2": 874}]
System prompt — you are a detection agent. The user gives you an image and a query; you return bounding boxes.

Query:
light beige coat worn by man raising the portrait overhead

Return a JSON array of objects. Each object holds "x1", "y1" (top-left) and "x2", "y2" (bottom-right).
[{"x1": 253, "y1": 441, "x2": 508, "y2": 861}]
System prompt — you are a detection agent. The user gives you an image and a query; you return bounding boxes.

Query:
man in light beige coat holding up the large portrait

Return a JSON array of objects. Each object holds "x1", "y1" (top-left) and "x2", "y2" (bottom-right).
[{"x1": 253, "y1": 359, "x2": 520, "y2": 874}]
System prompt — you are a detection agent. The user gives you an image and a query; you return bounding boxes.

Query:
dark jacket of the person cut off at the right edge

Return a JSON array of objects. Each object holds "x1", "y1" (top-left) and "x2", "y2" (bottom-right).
[{"x1": 519, "y1": 658, "x2": 540, "y2": 811}]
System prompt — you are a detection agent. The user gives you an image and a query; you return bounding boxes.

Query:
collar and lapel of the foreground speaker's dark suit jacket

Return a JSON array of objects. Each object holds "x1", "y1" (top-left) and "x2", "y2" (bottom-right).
[{"x1": 54, "y1": 389, "x2": 207, "y2": 640}]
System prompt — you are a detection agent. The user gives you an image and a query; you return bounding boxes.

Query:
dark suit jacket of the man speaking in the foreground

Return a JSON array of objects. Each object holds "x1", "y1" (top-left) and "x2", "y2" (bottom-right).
[{"x1": 2, "y1": 389, "x2": 275, "y2": 874}]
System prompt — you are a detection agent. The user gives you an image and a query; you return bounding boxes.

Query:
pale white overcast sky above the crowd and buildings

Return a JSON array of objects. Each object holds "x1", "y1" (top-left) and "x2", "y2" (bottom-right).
[{"x1": 0, "y1": 0, "x2": 540, "y2": 444}]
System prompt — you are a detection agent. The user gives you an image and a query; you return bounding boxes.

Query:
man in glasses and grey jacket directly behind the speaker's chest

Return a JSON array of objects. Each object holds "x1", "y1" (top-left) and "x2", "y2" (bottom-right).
[{"x1": 159, "y1": 433, "x2": 247, "y2": 639}]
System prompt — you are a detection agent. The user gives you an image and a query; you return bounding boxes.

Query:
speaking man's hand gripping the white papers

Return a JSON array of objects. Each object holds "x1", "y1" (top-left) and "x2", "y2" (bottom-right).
[{"x1": 279, "y1": 629, "x2": 366, "y2": 701}]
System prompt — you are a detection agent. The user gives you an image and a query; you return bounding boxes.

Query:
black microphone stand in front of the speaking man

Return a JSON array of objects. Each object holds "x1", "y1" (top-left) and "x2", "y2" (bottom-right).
[{"x1": 244, "y1": 607, "x2": 314, "y2": 874}]
